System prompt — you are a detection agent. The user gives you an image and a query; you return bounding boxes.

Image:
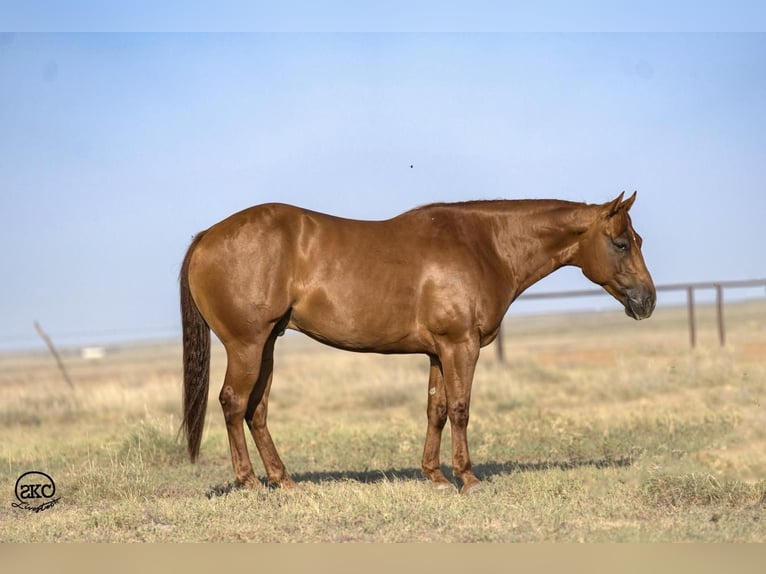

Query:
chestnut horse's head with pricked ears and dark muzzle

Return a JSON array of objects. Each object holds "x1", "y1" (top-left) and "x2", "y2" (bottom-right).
[{"x1": 578, "y1": 192, "x2": 657, "y2": 319}]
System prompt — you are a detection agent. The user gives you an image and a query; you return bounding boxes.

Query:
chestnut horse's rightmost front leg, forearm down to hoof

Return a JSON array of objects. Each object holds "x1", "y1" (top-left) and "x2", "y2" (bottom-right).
[{"x1": 439, "y1": 338, "x2": 481, "y2": 494}]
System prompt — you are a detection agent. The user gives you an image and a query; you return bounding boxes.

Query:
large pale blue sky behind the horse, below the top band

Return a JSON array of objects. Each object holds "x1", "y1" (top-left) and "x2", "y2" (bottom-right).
[{"x1": 0, "y1": 26, "x2": 766, "y2": 348}]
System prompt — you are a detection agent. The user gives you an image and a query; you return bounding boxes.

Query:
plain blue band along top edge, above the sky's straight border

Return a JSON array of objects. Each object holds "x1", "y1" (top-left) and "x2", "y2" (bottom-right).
[{"x1": 0, "y1": 0, "x2": 766, "y2": 32}]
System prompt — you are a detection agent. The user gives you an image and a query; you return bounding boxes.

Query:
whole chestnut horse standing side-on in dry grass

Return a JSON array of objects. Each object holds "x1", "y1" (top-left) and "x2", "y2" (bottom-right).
[{"x1": 180, "y1": 193, "x2": 656, "y2": 492}]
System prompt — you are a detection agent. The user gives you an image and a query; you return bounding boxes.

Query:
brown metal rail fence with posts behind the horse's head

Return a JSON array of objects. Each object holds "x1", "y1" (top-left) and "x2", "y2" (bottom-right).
[{"x1": 497, "y1": 279, "x2": 766, "y2": 361}]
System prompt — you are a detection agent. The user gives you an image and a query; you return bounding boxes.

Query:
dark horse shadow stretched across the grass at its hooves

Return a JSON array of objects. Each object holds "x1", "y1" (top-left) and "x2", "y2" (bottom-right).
[{"x1": 205, "y1": 456, "x2": 633, "y2": 498}]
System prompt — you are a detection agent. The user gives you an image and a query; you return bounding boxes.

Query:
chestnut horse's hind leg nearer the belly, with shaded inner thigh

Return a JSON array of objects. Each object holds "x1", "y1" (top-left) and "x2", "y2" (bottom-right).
[{"x1": 245, "y1": 325, "x2": 295, "y2": 488}]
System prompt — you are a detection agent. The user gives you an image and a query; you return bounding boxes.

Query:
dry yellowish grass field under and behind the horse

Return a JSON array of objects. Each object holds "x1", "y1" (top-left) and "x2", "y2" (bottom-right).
[{"x1": 0, "y1": 301, "x2": 766, "y2": 542}]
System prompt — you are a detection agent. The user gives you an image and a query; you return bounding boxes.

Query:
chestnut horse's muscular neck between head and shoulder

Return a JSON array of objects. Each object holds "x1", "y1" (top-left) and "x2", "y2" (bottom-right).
[{"x1": 497, "y1": 200, "x2": 595, "y2": 299}]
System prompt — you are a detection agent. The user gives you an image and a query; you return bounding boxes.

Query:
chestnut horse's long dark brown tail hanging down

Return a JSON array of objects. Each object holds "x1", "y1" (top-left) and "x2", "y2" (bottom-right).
[{"x1": 180, "y1": 233, "x2": 210, "y2": 462}]
